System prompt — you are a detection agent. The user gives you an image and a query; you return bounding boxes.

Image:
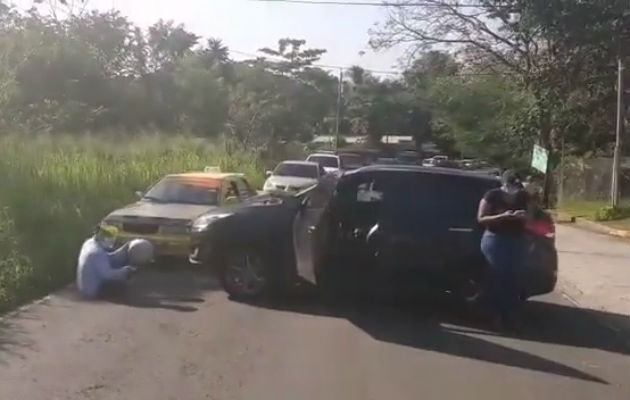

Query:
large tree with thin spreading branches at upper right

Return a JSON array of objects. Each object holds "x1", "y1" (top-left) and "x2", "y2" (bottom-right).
[{"x1": 371, "y1": 0, "x2": 630, "y2": 172}]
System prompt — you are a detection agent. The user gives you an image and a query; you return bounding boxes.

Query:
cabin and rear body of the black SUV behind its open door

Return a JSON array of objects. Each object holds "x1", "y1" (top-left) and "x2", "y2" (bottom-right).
[{"x1": 318, "y1": 166, "x2": 557, "y2": 299}]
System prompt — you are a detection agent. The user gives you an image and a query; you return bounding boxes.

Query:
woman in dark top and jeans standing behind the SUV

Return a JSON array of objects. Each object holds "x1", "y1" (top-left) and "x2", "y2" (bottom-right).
[{"x1": 477, "y1": 170, "x2": 529, "y2": 329}]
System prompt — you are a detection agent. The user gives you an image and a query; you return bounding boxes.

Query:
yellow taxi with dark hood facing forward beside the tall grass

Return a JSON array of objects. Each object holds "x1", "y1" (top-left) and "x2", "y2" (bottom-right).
[{"x1": 103, "y1": 170, "x2": 256, "y2": 257}]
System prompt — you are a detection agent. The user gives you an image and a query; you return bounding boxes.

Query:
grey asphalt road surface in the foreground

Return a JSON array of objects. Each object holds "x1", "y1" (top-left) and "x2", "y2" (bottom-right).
[{"x1": 0, "y1": 242, "x2": 630, "y2": 400}]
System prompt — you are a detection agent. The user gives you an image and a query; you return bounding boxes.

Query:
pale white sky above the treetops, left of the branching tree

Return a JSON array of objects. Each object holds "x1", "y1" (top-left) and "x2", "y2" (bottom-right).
[{"x1": 13, "y1": 0, "x2": 410, "y2": 70}]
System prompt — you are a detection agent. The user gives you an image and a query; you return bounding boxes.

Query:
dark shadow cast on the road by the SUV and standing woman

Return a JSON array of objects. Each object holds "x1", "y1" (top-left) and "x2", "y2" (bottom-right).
[{"x1": 246, "y1": 296, "x2": 629, "y2": 384}]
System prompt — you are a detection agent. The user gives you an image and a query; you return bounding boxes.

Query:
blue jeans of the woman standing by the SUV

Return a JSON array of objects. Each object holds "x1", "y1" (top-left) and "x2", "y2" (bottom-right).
[{"x1": 481, "y1": 231, "x2": 526, "y2": 318}]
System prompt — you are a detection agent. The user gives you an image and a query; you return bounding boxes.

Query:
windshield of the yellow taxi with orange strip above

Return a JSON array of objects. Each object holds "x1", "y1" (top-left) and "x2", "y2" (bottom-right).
[{"x1": 144, "y1": 178, "x2": 219, "y2": 206}]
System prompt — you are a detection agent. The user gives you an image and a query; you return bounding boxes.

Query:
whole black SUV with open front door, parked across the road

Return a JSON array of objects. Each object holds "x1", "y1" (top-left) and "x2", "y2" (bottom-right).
[{"x1": 193, "y1": 166, "x2": 557, "y2": 300}]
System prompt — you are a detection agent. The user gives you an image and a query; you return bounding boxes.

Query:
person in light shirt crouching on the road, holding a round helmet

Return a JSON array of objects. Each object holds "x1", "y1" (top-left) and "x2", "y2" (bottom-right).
[{"x1": 76, "y1": 225, "x2": 153, "y2": 299}]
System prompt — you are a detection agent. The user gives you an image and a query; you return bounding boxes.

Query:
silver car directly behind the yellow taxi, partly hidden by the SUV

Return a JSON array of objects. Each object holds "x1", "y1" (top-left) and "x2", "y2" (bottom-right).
[{"x1": 263, "y1": 161, "x2": 326, "y2": 192}]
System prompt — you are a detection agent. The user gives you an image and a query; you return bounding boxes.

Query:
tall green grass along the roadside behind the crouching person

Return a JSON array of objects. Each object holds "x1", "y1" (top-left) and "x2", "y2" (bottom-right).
[{"x1": 0, "y1": 135, "x2": 263, "y2": 311}]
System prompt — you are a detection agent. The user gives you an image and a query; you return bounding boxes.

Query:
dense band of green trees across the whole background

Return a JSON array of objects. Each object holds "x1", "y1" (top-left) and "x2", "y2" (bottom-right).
[{"x1": 0, "y1": 0, "x2": 630, "y2": 165}]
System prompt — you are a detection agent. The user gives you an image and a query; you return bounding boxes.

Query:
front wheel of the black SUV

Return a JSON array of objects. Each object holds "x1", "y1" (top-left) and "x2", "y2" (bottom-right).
[{"x1": 220, "y1": 249, "x2": 272, "y2": 300}]
